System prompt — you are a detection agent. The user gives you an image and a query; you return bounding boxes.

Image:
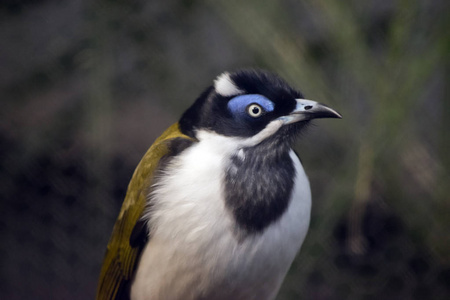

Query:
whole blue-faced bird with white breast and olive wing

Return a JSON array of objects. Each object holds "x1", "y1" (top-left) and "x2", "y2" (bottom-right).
[{"x1": 96, "y1": 69, "x2": 341, "y2": 300}]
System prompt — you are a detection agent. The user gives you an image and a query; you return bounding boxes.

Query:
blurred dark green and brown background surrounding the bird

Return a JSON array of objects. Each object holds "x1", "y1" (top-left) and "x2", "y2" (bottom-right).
[{"x1": 0, "y1": 0, "x2": 450, "y2": 300}]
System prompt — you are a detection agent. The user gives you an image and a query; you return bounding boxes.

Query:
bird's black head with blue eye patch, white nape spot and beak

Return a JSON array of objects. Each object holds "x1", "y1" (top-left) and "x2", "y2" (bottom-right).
[{"x1": 180, "y1": 70, "x2": 341, "y2": 146}]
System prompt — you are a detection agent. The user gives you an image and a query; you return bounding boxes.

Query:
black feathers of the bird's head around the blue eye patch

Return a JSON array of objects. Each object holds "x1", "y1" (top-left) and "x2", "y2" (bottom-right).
[{"x1": 179, "y1": 69, "x2": 303, "y2": 141}]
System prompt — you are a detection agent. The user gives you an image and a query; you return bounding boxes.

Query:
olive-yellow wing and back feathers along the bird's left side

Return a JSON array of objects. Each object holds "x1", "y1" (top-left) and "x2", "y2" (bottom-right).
[{"x1": 96, "y1": 123, "x2": 192, "y2": 300}]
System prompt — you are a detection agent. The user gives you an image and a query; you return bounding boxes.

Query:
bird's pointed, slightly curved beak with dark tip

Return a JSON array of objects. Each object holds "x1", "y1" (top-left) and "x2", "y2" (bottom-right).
[{"x1": 279, "y1": 99, "x2": 342, "y2": 125}]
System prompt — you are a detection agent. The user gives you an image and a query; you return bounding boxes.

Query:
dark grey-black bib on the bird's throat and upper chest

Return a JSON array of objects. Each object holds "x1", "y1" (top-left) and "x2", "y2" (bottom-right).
[{"x1": 225, "y1": 146, "x2": 295, "y2": 234}]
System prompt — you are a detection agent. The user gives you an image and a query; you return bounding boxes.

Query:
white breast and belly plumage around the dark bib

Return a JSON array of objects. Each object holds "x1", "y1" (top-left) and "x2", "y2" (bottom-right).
[{"x1": 131, "y1": 136, "x2": 311, "y2": 300}]
